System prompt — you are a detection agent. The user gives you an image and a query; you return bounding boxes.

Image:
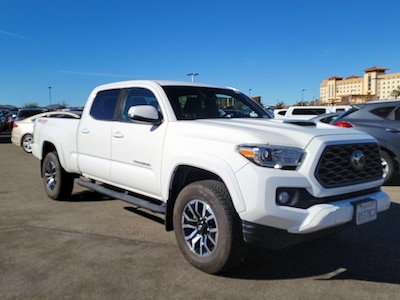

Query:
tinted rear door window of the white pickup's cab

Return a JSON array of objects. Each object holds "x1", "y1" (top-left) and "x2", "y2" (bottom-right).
[{"x1": 90, "y1": 90, "x2": 120, "y2": 121}]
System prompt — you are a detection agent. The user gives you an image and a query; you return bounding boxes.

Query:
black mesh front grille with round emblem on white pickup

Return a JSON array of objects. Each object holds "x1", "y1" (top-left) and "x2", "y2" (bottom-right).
[{"x1": 315, "y1": 143, "x2": 382, "y2": 188}]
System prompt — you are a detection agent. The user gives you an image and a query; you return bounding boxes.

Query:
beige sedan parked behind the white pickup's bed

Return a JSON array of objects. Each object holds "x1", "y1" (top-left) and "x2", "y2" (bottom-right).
[{"x1": 11, "y1": 111, "x2": 80, "y2": 153}]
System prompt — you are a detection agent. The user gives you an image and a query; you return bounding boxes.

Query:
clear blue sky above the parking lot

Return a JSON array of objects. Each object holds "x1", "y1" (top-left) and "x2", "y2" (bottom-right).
[{"x1": 0, "y1": 0, "x2": 400, "y2": 106}]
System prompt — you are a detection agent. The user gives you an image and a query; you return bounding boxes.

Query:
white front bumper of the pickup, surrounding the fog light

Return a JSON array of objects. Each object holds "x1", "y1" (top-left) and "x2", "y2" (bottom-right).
[{"x1": 237, "y1": 166, "x2": 390, "y2": 235}]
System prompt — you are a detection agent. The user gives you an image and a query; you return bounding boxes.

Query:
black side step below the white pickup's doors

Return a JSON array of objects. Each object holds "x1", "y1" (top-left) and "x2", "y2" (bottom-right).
[{"x1": 76, "y1": 179, "x2": 167, "y2": 215}]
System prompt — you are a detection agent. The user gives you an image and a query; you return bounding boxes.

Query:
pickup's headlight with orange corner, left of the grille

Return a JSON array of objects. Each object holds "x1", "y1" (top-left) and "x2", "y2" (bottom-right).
[{"x1": 238, "y1": 145, "x2": 304, "y2": 170}]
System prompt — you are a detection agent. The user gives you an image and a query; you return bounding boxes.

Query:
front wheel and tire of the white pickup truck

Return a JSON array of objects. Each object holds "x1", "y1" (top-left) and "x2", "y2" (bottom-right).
[{"x1": 173, "y1": 180, "x2": 246, "y2": 274}]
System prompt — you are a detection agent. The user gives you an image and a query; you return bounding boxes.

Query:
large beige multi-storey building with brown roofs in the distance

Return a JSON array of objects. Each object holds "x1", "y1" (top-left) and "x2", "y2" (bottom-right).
[{"x1": 320, "y1": 67, "x2": 400, "y2": 104}]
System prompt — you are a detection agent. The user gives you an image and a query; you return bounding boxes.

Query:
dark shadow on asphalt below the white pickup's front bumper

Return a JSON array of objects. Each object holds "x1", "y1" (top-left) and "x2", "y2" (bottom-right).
[{"x1": 225, "y1": 203, "x2": 400, "y2": 283}]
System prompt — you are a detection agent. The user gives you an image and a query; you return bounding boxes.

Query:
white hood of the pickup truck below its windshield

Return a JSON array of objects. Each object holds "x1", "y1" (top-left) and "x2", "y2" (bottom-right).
[{"x1": 169, "y1": 119, "x2": 370, "y2": 149}]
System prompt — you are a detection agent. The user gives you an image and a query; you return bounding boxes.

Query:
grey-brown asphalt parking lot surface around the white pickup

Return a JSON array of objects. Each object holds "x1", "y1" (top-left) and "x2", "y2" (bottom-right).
[{"x1": 0, "y1": 134, "x2": 400, "y2": 300}]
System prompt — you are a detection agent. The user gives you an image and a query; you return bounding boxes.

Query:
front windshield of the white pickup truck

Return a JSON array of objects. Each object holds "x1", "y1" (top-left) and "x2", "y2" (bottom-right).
[{"x1": 163, "y1": 86, "x2": 269, "y2": 120}]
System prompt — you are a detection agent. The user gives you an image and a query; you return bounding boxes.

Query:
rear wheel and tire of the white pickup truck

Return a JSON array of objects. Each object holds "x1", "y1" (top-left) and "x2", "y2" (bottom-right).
[{"x1": 42, "y1": 152, "x2": 74, "y2": 200}]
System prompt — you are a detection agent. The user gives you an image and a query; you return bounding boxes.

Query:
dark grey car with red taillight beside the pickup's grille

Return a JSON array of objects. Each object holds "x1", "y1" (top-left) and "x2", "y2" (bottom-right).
[{"x1": 331, "y1": 100, "x2": 400, "y2": 184}]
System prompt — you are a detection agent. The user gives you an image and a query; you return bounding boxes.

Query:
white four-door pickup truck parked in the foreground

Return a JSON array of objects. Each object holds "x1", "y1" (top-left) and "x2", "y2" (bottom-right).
[{"x1": 32, "y1": 81, "x2": 390, "y2": 273}]
